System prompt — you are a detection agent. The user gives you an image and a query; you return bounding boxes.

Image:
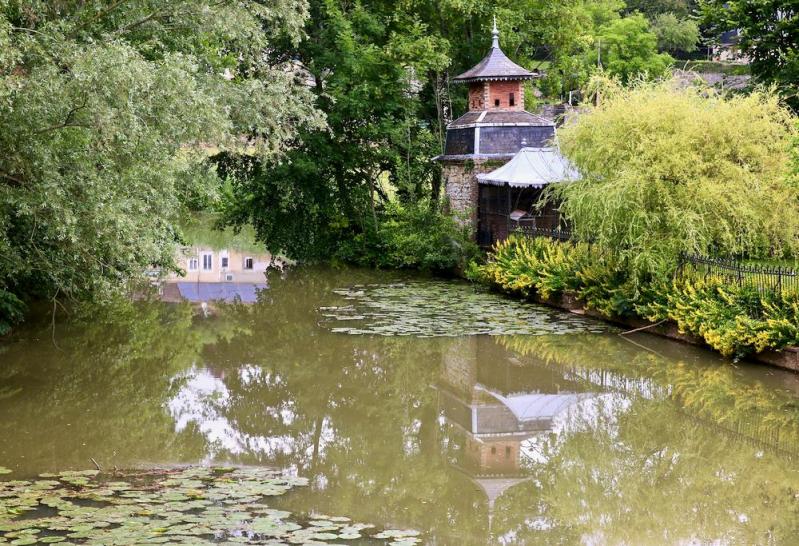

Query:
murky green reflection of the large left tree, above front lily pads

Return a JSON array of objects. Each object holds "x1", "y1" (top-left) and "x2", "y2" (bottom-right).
[{"x1": 0, "y1": 300, "x2": 238, "y2": 472}]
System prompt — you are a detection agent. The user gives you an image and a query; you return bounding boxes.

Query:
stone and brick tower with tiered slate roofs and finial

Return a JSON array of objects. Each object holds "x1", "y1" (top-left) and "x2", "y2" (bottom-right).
[{"x1": 436, "y1": 19, "x2": 555, "y2": 233}]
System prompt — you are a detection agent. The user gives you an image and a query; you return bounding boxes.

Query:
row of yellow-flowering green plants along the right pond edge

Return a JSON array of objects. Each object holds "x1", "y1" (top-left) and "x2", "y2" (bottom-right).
[{"x1": 476, "y1": 236, "x2": 799, "y2": 358}]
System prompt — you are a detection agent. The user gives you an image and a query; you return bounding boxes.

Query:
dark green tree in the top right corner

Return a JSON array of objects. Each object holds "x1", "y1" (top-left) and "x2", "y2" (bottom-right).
[{"x1": 701, "y1": 0, "x2": 799, "y2": 108}]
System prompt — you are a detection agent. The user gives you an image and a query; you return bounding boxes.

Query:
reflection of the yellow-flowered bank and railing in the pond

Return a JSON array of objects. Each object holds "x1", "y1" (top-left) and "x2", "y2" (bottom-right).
[{"x1": 498, "y1": 335, "x2": 799, "y2": 453}]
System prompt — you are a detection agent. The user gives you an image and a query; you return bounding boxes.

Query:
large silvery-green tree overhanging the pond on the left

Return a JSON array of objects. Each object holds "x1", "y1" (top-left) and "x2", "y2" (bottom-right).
[{"x1": 0, "y1": 0, "x2": 321, "y2": 333}]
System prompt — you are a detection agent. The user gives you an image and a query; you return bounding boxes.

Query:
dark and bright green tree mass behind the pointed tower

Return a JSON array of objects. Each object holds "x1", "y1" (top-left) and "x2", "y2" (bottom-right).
[{"x1": 222, "y1": 0, "x2": 670, "y2": 258}]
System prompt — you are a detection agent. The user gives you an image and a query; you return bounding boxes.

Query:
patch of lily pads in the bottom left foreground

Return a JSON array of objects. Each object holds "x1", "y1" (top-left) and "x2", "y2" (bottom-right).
[{"x1": 0, "y1": 468, "x2": 420, "y2": 546}]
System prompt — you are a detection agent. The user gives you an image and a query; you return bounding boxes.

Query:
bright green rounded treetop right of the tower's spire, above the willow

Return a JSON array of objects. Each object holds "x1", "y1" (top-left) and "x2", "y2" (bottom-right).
[{"x1": 588, "y1": 14, "x2": 674, "y2": 82}]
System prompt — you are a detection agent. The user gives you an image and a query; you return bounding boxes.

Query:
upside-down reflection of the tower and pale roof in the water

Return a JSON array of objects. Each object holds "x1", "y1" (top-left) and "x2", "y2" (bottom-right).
[{"x1": 437, "y1": 336, "x2": 590, "y2": 525}]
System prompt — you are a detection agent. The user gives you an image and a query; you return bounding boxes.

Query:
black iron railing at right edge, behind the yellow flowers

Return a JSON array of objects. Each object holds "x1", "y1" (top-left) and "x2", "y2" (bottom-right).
[{"x1": 677, "y1": 254, "x2": 799, "y2": 292}]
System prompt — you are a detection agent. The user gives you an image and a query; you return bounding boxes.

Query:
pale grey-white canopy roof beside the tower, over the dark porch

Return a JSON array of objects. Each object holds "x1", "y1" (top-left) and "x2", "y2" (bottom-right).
[{"x1": 477, "y1": 148, "x2": 580, "y2": 188}]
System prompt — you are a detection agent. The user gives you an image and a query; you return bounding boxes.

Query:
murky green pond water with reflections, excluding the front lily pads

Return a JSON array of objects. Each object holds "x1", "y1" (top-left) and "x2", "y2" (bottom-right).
[{"x1": 0, "y1": 268, "x2": 799, "y2": 546}]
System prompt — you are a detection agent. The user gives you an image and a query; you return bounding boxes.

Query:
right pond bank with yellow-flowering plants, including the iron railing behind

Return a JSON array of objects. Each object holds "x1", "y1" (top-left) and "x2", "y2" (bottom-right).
[{"x1": 467, "y1": 235, "x2": 799, "y2": 371}]
